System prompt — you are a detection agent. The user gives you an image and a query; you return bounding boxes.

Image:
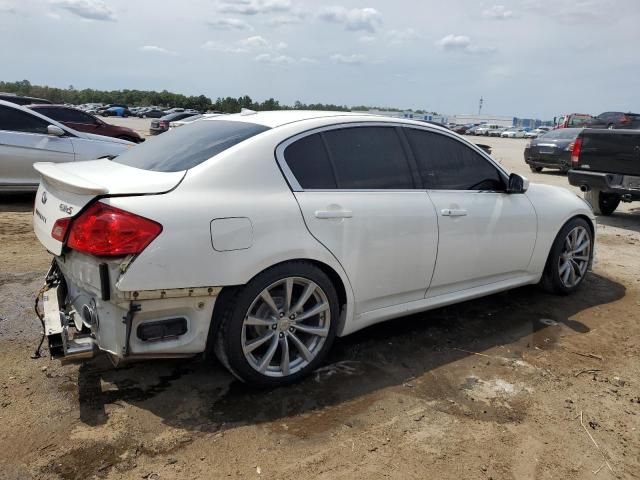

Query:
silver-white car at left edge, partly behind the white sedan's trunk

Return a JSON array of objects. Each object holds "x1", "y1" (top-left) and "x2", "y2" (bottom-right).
[{"x1": 0, "y1": 100, "x2": 136, "y2": 193}]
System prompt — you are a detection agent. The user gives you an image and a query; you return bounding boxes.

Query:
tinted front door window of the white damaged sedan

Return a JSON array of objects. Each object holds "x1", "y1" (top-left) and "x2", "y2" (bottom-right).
[{"x1": 405, "y1": 128, "x2": 505, "y2": 191}]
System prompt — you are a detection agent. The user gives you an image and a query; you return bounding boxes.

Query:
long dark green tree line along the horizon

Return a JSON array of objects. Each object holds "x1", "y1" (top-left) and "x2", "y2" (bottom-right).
[{"x1": 0, "y1": 80, "x2": 430, "y2": 113}]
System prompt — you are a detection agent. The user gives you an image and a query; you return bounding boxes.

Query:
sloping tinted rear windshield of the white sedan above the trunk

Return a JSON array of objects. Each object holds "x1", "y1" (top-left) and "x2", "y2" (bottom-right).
[{"x1": 113, "y1": 120, "x2": 269, "y2": 172}]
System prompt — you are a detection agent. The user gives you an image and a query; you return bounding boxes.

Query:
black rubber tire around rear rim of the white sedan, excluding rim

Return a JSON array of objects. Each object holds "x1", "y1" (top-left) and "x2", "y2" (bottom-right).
[{"x1": 213, "y1": 261, "x2": 340, "y2": 388}]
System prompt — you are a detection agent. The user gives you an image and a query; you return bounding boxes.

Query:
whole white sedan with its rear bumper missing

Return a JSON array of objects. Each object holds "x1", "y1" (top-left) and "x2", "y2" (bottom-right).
[{"x1": 33, "y1": 110, "x2": 595, "y2": 386}]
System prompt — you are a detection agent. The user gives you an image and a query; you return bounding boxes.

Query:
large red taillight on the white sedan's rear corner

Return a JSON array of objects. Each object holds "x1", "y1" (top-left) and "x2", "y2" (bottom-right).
[{"x1": 64, "y1": 202, "x2": 162, "y2": 257}]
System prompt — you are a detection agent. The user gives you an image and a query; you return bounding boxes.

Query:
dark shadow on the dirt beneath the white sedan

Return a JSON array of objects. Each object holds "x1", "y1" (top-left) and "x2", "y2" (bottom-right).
[{"x1": 78, "y1": 274, "x2": 625, "y2": 432}]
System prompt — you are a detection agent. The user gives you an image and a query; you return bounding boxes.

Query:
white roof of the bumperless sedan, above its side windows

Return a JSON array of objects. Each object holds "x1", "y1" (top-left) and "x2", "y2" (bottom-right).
[{"x1": 199, "y1": 110, "x2": 450, "y2": 132}]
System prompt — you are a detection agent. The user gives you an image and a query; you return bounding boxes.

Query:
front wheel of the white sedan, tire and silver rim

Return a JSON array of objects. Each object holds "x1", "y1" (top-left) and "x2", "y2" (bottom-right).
[{"x1": 541, "y1": 218, "x2": 593, "y2": 295}]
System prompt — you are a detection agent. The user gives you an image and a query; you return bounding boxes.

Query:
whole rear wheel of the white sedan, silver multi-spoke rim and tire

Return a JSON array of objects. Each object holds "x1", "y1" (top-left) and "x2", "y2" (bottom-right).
[{"x1": 214, "y1": 262, "x2": 339, "y2": 387}]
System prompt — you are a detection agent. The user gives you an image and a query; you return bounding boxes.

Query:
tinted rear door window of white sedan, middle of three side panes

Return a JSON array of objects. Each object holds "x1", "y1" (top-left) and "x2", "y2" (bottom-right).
[{"x1": 322, "y1": 127, "x2": 413, "y2": 189}]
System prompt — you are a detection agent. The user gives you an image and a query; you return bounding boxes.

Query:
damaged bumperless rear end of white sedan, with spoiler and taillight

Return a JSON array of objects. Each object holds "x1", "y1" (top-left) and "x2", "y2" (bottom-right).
[{"x1": 33, "y1": 160, "x2": 209, "y2": 362}]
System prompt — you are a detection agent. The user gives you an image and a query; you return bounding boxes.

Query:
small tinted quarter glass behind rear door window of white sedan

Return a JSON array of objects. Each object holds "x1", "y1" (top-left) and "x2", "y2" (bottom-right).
[{"x1": 284, "y1": 133, "x2": 337, "y2": 189}]
